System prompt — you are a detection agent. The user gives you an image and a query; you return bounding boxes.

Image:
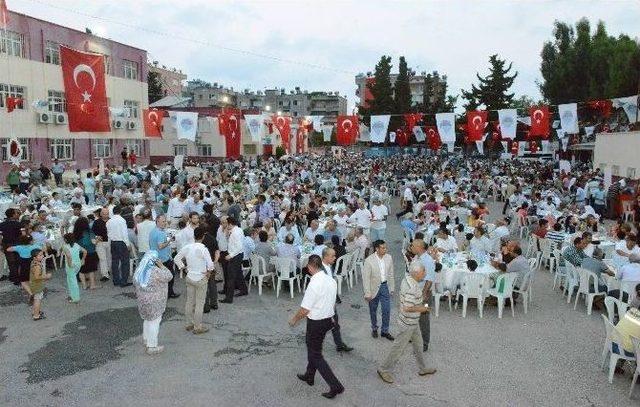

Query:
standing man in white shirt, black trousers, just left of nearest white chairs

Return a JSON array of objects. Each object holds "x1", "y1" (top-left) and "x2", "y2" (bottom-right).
[{"x1": 220, "y1": 216, "x2": 248, "y2": 304}]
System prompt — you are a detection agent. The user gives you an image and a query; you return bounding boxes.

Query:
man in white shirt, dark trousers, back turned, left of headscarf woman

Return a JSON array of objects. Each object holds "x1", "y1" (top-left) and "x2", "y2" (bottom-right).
[{"x1": 107, "y1": 205, "x2": 132, "y2": 287}]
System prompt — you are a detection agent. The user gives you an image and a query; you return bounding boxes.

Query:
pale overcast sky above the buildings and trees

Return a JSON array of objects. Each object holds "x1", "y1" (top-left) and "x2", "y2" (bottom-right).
[{"x1": 7, "y1": 0, "x2": 640, "y2": 108}]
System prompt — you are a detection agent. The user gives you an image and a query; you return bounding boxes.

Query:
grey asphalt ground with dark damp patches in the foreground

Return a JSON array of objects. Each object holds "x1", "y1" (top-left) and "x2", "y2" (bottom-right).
[{"x1": 0, "y1": 199, "x2": 640, "y2": 406}]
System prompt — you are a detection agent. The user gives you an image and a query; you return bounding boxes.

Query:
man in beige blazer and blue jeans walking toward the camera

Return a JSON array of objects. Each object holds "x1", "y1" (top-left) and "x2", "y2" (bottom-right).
[{"x1": 362, "y1": 240, "x2": 395, "y2": 341}]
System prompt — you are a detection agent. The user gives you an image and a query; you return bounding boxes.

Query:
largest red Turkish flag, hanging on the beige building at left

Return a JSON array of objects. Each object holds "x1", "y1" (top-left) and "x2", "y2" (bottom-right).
[{"x1": 60, "y1": 46, "x2": 111, "y2": 132}]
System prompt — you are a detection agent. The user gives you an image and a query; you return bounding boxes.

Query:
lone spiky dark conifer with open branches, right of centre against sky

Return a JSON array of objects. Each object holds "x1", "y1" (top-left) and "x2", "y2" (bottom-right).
[{"x1": 462, "y1": 54, "x2": 518, "y2": 110}]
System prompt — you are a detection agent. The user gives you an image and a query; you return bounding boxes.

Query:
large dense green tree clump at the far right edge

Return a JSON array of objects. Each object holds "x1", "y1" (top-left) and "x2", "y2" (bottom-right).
[{"x1": 538, "y1": 18, "x2": 640, "y2": 104}]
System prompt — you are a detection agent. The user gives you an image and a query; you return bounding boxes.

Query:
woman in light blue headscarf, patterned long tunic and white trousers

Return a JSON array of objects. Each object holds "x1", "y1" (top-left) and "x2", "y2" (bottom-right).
[{"x1": 133, "y1": 250, "x2": 173, "y2": 355}]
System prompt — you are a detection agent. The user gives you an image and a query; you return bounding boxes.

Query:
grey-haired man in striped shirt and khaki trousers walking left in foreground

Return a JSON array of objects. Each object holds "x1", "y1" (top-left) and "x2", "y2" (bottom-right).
[{"x1": 378, "y1": 263, "x2": 436, "y2": 383}]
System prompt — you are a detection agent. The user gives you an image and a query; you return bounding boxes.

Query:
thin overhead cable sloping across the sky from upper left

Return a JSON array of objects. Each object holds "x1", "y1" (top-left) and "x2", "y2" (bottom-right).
[{"x1": 20, "y1": 0, "x2": 357, "y2": 75}]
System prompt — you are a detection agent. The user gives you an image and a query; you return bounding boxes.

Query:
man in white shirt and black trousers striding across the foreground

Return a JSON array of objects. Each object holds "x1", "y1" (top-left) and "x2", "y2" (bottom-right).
[{"x1": 289, "y1": 255, "x2": 344, "y2": 399}]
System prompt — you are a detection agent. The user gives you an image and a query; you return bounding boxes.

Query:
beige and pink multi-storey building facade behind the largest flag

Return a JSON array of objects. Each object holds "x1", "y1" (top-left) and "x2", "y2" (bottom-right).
[{"x1": 0, "y1": 12, "x2": 149, "y2": 175}]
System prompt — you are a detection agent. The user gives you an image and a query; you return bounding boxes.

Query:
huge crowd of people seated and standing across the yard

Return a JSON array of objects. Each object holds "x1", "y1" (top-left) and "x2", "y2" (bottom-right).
[{"x1": 0, "y1": 153, "x2": 640, "y2": 398}]
